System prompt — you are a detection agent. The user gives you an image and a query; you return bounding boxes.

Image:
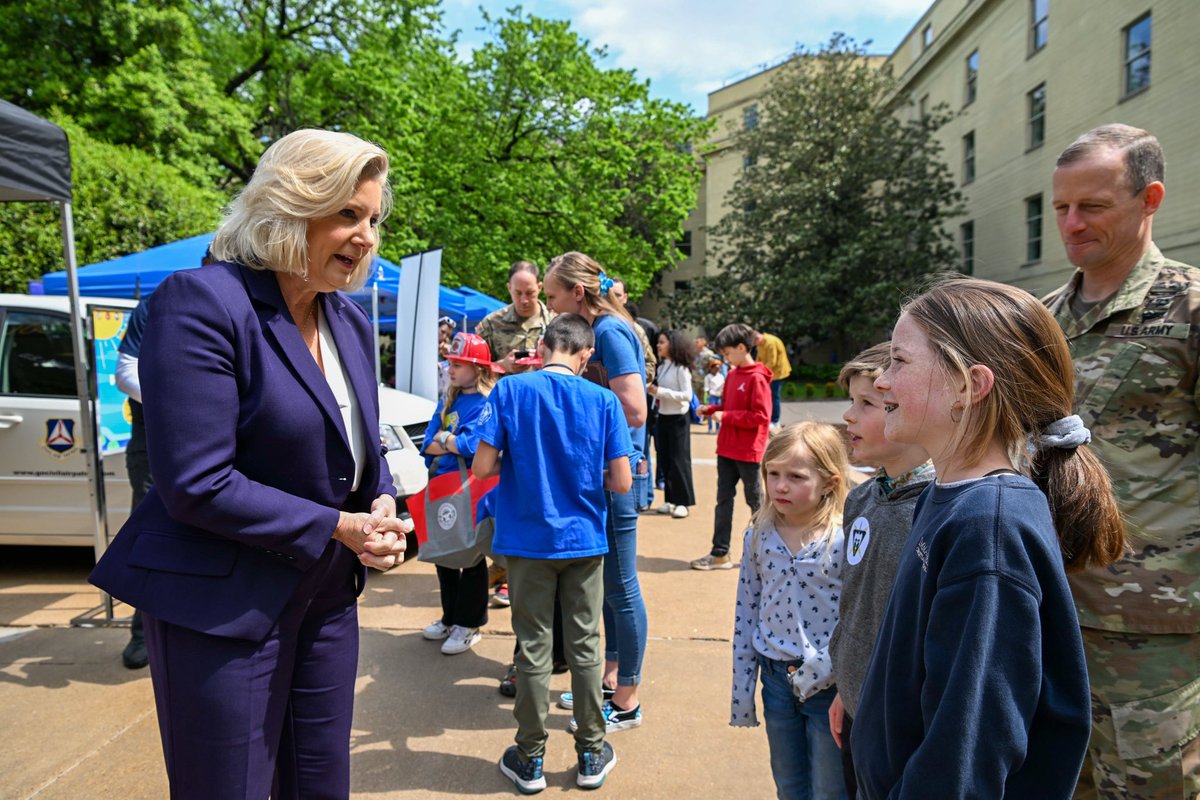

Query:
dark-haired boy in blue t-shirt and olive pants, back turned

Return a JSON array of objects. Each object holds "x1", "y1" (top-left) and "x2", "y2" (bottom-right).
[{"x1": 472, "y1": 314, "x2": 634, "y2": 794}]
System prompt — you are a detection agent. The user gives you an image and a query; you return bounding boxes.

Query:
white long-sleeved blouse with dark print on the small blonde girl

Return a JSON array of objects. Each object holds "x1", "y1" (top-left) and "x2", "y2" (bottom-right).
[{"x1": 730, "y1": 525, "x2": 845, "y2": 727}]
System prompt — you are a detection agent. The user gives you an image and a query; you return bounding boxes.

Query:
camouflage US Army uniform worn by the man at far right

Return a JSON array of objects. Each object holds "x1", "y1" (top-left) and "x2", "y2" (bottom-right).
[{"x1": 1044, "y1": 245, "x2": 1200, "y2": 800}]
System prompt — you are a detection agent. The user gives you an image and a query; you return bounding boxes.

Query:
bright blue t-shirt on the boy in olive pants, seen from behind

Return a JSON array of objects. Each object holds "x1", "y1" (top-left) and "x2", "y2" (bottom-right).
[{"x1": 475, "y1": 369, "x2": 634, "y2": 559}]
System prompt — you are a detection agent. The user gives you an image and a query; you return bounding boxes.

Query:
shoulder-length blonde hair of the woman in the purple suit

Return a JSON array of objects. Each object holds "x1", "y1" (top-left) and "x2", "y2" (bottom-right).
[{"x1": 212, "y1": 128, "x2": 391, "y2": 291}]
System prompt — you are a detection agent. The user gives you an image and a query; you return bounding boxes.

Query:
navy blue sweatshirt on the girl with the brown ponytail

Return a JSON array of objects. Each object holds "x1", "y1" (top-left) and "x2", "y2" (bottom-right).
[{"x1": 851, "y1": 474, "x2": 1091, "y2": 800}]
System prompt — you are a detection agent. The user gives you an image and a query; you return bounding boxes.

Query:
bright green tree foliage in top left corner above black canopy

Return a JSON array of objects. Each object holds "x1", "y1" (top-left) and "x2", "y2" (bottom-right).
[{"x1": 0, "y1": 0, "x2": 258, "y2": 184}]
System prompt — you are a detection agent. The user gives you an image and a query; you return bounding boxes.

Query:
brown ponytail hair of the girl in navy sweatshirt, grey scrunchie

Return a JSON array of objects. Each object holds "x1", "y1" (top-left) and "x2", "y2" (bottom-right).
[{"x1": 902, "y1": 277, "x2": 1124, "y2": 571}]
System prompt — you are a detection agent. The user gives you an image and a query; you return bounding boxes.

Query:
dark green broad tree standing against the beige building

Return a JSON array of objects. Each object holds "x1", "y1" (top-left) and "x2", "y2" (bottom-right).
[{"x1": 670, "y1": 35, "x2": 961, "y2": 347}]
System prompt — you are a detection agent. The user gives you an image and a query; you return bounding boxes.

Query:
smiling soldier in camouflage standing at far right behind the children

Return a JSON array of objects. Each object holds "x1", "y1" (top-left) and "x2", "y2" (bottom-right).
[{"x1": 1045, "y1": 125, "x2": 1200, "y2": 800}]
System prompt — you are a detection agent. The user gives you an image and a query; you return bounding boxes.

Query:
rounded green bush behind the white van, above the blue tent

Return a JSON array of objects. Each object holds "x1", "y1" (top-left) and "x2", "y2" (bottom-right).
[{"x1": 0, "y1": 116, "x2": 224, "y2": 291}]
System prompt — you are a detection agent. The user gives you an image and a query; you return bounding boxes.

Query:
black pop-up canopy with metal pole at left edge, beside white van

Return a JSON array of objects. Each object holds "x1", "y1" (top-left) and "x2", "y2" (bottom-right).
[{"x1": 0, "y1": 100, "x2": 113, "y2": 606}]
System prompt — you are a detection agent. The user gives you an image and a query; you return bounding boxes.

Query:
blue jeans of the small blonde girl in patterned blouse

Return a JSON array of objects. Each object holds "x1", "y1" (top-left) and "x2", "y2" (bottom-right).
[{"x1": 758, "y1": 655, "x2": 846, "y2": 800}]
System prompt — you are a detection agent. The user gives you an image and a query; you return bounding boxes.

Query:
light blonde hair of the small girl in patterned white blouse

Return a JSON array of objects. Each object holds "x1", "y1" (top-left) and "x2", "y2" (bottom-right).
[{"x1": 752, "y1": 421, "x2": 850, "y2": 552}]
